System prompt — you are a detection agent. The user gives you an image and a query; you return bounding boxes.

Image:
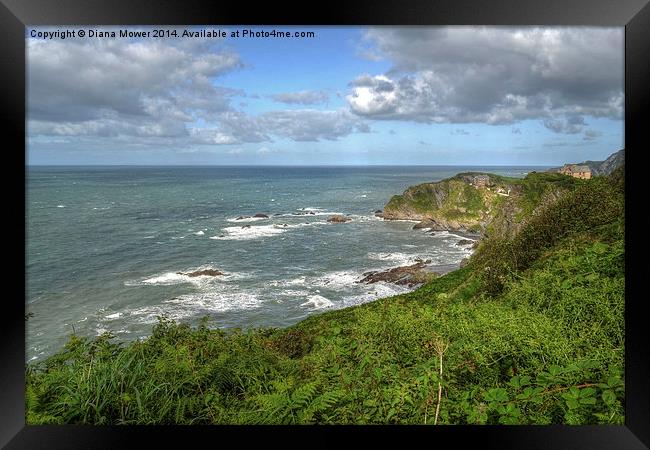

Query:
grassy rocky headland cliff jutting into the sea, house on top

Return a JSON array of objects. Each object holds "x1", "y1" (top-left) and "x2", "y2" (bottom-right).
[{"x1": 381, "y1": 172, "x2": 579, "y2": 236}]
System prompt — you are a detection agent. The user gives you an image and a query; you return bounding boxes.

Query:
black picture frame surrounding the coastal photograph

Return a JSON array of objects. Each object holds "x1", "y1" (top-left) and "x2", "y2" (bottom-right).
[{"x1": 0, "y1": 0, "x2": 650, "y2": 449}]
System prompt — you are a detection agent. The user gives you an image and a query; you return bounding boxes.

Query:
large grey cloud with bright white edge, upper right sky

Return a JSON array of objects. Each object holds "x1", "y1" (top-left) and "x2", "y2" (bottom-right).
[{"x1": 346, "y1": 27, "x2": 624, "y2": 133}]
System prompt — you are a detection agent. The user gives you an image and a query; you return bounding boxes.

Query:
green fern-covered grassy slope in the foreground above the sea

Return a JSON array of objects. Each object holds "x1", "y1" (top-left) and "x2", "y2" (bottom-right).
[{"x1": 27, "y1": 169, "x2": 624, "y2": 424}]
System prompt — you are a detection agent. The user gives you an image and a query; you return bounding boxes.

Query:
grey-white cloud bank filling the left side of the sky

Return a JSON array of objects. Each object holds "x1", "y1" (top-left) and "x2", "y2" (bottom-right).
[{"x1": 27, "y1": 35, "x2": 369, "y2": 148}]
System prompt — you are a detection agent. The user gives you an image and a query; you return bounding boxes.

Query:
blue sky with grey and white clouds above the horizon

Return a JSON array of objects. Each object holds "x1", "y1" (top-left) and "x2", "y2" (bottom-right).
[{"x1": 26, "y1": 26, "x2": 625, "y2": 166}]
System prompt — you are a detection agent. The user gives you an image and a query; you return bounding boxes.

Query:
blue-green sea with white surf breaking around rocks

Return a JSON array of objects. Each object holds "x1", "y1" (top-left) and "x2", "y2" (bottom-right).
[{"x1": 25, "y1": 166, "x2": 544, "y2": 361}]
